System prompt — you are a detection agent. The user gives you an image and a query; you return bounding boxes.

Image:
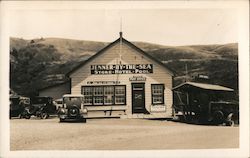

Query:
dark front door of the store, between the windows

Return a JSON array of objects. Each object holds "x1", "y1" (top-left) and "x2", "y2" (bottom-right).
[{"x1": 132, "y1": 83, "x2": 146, "y2": 113}]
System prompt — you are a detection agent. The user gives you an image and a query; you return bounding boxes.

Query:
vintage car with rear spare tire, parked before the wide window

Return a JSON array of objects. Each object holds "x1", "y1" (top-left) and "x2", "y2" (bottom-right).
[{"x1": 58, "y1": 94, "x2": 88, "y2": 123}]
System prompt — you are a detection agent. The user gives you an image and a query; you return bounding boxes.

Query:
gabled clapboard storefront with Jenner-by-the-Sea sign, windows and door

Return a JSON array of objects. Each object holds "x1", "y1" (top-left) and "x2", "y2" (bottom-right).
[{"x1": 68, "y1": 34, "x2": 173, "y2": 118}]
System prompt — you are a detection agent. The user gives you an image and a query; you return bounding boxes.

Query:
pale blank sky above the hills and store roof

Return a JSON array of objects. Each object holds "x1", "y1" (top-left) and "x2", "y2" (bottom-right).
[{"x1": 9, "y1": 8, "x2": 238, "y2": 45}]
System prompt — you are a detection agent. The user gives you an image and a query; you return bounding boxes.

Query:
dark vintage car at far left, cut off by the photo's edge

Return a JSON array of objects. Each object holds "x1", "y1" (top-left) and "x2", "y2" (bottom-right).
[{"x1": 10, "y1": 95, "x2": 30, "y2": 118}]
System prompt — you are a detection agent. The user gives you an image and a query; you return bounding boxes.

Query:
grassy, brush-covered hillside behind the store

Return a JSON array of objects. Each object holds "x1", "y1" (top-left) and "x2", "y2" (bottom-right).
[{"x1": 10, "y1": 38, "x2": 238, "y2": 95}]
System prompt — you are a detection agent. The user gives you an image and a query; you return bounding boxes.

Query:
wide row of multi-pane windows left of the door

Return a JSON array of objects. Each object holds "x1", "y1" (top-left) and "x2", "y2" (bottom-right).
[{"x1": 82, "y1": 85, "x2": 126, "y2": 105}]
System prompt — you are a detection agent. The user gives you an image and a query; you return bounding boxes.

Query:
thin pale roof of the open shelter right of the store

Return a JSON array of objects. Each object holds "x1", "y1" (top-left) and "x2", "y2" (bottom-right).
[{"x1": 173, "y1": 82, "x2": 234, "y2": 91}]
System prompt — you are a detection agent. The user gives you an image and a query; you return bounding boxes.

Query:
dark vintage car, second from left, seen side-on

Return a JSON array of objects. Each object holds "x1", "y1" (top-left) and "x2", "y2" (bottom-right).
[{"x1": 23, "y1": 97, "x2": 56, "y2": 119}]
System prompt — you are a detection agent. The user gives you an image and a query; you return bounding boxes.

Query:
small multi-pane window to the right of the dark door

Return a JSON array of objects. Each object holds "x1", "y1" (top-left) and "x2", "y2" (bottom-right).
[{"x1": 151, "y1": 84, "x2": 164, "y2": 105}]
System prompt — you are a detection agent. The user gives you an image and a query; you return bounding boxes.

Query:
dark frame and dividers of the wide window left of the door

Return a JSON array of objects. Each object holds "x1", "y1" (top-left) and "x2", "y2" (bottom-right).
[{"x1": 81, "y1": 85, "x2": 127, "y2": 106}]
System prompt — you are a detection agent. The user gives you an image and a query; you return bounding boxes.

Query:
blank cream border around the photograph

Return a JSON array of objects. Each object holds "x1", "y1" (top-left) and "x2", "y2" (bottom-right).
[{"x1": 0, "y1": 0, "x2": 249, "y2": 158}]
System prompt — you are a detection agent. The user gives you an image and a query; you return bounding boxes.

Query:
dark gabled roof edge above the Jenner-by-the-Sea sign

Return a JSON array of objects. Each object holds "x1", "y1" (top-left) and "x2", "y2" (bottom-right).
[{"x1": 66, "y1": 37, "x2": 174, "y2": 76}]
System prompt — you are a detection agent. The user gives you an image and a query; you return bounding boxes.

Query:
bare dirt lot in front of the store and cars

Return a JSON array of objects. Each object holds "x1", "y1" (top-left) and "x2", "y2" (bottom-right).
[{"x1": 10, "y1": 118, "x2": 239, "y2": 150}]
